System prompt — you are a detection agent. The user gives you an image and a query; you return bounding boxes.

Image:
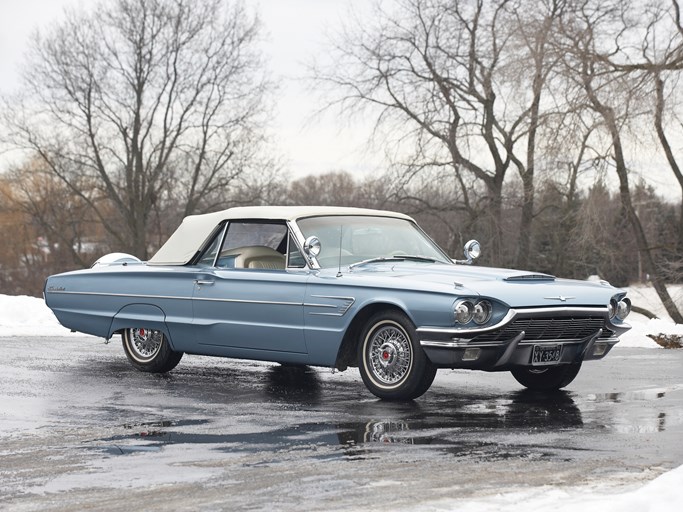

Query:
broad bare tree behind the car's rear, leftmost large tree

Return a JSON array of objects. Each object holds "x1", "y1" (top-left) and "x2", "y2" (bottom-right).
[{"x1": 3, "y1": 0, "x2": 276, "y2": 258}]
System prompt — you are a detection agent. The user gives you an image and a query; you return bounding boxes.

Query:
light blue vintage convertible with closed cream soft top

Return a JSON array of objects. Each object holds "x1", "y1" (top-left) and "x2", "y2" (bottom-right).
[{"x1": 44, "y1": 207, "x2": 631, "y2": 400}]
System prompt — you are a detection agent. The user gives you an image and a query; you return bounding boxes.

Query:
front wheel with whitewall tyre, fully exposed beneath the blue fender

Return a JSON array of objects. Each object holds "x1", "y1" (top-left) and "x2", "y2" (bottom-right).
[{"x1": 358, "y1": 311, "x2": 436, "y2": 400}]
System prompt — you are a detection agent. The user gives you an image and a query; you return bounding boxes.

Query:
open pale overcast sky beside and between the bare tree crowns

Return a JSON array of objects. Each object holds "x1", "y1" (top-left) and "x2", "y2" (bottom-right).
[{"x1": 0, "y1": 0, "x2": 382, "y2": 180}]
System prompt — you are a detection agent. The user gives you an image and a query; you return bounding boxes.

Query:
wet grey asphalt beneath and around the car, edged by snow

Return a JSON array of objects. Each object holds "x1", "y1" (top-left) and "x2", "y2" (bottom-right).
[{"x1": 0, "y1": 337, "x2": 683, "y2": 511}]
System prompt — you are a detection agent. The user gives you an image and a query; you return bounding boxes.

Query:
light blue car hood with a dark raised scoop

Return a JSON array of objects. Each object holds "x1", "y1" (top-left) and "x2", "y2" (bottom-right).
[{"x1": 344, "y1": 262, "x2": 621, "y2": 307}]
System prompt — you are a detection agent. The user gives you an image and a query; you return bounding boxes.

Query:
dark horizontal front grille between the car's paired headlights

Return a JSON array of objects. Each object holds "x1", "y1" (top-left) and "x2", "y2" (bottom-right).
[{"x1": 472, "y1": 317, "x2": 614, "y2": 343}]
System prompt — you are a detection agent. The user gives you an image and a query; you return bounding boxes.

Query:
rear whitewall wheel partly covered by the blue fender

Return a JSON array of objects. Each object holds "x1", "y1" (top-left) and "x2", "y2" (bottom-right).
[{"x1": 121, "y1": 327, "x2": 183, "y2": 373}]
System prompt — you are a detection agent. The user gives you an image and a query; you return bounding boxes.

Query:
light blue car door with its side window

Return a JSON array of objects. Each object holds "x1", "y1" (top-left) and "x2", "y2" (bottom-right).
[{"x1": 192, "y1": 220, "x2": 309, "y2": 359}]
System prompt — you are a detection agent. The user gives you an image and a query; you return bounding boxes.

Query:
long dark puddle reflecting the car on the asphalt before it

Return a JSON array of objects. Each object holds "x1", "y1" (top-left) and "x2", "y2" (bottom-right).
[{"x1": 88, "y1": 391, "x2": 583, "y2": 460}]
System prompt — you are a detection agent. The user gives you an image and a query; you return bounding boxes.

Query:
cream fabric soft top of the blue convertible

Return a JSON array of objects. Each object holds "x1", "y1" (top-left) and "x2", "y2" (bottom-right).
[{"x1": 147, "y1": 206, "x2": 412, "y2": 265}]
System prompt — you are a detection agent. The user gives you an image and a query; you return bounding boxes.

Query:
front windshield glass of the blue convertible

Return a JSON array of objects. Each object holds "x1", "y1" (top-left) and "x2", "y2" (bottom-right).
[{"x1": 297, "y1": 215, "x2": 452, "y2": 268}]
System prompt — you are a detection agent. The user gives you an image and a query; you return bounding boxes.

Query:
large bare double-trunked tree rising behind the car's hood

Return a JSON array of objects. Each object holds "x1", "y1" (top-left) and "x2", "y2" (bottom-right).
[{"x1": 317, "y1": 0, "x2": 564, "y2": 266}]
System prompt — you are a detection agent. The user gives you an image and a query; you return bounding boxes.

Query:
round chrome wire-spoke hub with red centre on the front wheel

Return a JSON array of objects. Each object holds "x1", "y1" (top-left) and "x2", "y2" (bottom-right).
[{"x1": 368, "y1": 326, "x2": 412, "y2": 384}]
